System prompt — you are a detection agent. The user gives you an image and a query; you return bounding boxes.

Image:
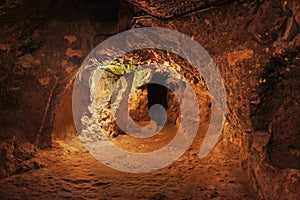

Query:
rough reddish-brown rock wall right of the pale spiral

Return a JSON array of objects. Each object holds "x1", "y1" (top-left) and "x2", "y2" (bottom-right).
[{"x1": 129, "y1": 1, "x2": 299, "y2": 199}]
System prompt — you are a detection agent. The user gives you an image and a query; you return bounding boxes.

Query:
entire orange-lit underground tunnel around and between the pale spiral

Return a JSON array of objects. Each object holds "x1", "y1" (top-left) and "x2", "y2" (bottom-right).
[{"x1": 0, "y1": 0, "x2": 300, "y2": 200}]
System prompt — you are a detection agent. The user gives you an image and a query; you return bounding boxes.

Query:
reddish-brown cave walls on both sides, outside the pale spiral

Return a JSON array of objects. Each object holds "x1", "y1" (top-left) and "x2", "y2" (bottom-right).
[{"x1": 0, "y1": 0, "x2": 300, "y2": 199}]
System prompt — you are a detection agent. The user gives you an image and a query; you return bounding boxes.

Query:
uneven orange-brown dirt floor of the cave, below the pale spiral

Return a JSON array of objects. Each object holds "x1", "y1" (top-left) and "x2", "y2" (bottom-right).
[{"x1": 0, "y1": 125, "x2": 257, "y2": 200}]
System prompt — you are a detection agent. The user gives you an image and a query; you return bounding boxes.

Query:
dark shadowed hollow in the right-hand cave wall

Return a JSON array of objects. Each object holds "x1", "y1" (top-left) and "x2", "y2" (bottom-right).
[{"x1": 253, "y1": 50, "x2": 300, "y2": 169}]
